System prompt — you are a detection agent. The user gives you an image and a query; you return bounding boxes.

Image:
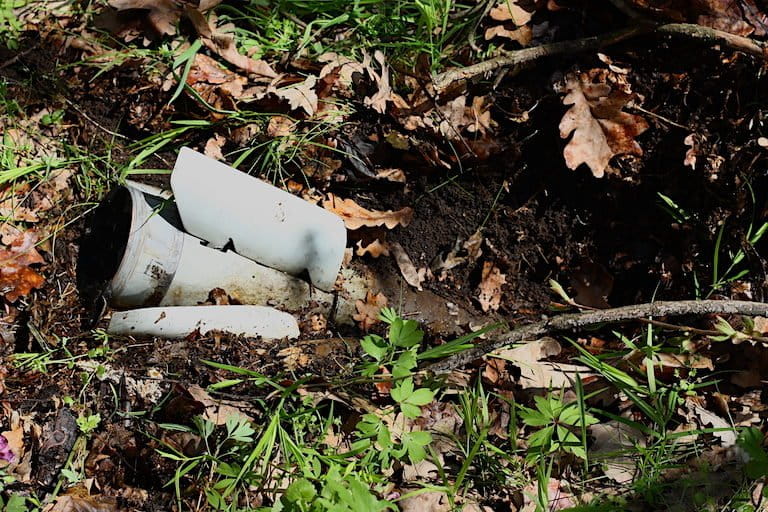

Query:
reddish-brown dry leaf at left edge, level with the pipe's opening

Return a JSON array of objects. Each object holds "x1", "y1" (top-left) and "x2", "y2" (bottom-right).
[{"x1": 0, "y1": 231, "x2": 45, "y2": 302}]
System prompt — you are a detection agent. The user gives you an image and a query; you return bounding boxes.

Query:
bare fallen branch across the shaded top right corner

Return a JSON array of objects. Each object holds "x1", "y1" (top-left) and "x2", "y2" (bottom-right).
[{"x1": 433, "y1": 21, "x2": 768, "y2": 95}]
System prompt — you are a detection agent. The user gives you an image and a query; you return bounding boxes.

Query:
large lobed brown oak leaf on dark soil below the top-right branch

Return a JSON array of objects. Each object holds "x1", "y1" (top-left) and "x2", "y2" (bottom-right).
[{"x1": 560, "y1": 73, "x2": 648, "y2": 178}]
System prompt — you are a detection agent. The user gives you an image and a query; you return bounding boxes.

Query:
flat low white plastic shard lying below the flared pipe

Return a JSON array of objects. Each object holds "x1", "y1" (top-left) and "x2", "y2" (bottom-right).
[{"x1": 107, "y1": 306, "x2": 299, "y2": 340}]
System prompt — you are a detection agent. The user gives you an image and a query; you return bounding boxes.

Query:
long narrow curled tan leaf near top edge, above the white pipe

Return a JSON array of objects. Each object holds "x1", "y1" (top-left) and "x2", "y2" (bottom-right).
[{"x1": 185, "y1": 7, "x2": 277, "y2": 80}]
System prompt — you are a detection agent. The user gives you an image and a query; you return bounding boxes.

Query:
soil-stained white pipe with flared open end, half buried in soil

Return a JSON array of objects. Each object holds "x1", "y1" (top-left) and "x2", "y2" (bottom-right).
[{"x1": 105, "y1": 186, "x2": 367, "y2": 324}]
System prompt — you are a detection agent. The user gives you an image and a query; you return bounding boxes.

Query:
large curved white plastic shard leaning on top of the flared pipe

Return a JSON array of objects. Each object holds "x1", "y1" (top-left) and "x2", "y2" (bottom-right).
[{"x1": 171, "y1": 148, "x2": 347, "y2": 291}]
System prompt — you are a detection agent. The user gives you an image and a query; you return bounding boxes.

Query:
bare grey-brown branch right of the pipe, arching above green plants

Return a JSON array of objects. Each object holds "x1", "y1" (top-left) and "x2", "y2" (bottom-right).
[{"x1": 424, "y1": 300, "x2": 768, "y2": 374}]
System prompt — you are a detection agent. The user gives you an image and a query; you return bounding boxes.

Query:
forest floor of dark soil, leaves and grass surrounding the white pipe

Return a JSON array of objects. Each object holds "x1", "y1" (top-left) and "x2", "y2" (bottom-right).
[{"x1": 0, "y1": 0, "x2": 768, "y2": 512}]
